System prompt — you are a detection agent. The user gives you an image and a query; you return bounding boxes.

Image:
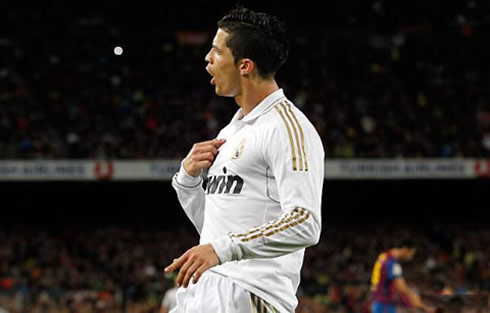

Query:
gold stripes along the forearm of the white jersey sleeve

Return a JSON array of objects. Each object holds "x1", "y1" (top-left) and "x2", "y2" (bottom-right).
[{"x1": 231, "y1": 208, "x2": 311, "y2": 242}]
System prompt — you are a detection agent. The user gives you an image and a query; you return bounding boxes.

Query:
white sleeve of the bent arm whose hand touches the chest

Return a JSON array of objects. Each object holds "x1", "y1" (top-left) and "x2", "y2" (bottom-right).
[{"x1": 172, "y1": 164, "x2": 205, "y2": 234}]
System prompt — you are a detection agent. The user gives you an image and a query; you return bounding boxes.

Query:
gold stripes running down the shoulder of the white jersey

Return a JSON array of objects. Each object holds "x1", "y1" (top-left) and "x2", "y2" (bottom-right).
[{"x1": 274, "y1": 101, "x2": 308, "y2": 171}]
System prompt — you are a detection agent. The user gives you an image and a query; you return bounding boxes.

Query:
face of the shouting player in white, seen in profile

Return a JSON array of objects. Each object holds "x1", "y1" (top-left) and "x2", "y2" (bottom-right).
[{"x1": 205, "y1": 29, "x2": 240, "y2": 97}]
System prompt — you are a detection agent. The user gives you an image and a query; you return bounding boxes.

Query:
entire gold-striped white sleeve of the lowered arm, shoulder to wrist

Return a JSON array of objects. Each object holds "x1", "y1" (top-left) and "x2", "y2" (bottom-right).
[{"x1": 212, "y1": 106, "x2": 324, "y2": 263}]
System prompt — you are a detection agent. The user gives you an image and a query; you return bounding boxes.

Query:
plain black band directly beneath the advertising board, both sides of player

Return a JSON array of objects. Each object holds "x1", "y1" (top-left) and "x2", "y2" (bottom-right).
[{"x1": 0, "y1": 179, "x2": 490, "y2": 229}]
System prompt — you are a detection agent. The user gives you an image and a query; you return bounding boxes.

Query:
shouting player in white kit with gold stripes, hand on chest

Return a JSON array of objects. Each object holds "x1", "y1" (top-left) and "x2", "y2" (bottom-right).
[{"x1": 165, "y1": 8, "x2": 324, "y2": 313}]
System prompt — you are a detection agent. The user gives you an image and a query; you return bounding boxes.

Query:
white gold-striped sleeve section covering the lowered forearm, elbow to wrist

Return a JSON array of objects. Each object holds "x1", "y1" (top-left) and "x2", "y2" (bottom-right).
[{"x1": 211, "y1": 208, "x2": 321, "y2": 263}]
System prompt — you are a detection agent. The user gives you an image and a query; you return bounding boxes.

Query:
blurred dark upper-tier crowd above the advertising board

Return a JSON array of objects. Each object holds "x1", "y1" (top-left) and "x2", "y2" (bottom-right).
[{"x1": 0, "y1": 0, "x2": 490, "y2": 159}]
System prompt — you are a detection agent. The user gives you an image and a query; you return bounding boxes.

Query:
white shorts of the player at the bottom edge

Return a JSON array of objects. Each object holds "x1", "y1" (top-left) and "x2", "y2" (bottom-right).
[{"x1": 170, "y1": 271, "x2": 279, "y2": 313}]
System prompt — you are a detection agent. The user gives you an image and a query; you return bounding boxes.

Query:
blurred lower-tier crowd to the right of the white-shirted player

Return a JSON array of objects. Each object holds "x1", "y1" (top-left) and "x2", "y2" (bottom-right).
[{"x1": 299, "y1": 225, "x2": 490, "y2": 313}]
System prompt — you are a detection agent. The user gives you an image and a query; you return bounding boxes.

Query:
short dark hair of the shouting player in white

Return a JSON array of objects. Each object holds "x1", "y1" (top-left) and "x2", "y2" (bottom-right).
[{"x1": 218, "y1": 8, "x2": 289, "y2": 78}]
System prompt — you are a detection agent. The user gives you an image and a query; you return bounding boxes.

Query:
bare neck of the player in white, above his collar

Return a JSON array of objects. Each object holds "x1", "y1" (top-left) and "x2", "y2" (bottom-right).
[{"x1": 235, "y1": 79, "x2": 279, "y2": 115}]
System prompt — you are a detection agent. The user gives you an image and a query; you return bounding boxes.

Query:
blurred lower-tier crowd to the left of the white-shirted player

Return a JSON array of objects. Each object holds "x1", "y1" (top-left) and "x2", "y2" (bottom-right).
[{"x1": 0, "y1": 227, "x2": 197, "y2": 313}]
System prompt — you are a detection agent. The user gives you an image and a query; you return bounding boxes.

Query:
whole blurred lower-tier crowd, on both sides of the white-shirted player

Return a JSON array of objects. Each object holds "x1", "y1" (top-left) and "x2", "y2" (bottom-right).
[{"x1": 0, "y1": 224, "x2": 490, "y2": 313}]
